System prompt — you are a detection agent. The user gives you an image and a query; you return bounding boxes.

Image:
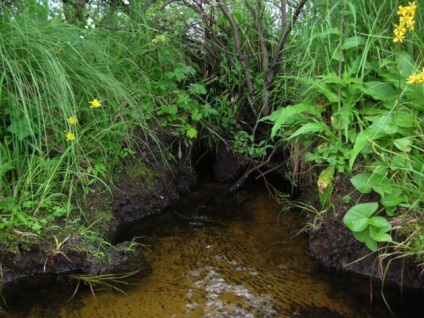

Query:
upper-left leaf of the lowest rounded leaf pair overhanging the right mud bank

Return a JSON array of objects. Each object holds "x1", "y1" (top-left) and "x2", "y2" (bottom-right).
[{"x1": 343, "y1": 202, "x2": 378, "y2": 232}]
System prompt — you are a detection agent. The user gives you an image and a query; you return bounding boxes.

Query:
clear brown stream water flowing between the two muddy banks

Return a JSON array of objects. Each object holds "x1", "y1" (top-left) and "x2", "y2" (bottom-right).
[{"x1": 1, "y1": 183, "x2": 422, "y2": 318}]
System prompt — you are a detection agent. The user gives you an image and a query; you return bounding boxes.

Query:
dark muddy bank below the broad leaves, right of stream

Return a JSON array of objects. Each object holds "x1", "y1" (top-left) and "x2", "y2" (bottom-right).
[{"x1": 303, "y1": 178, "x2": 424, "y2": 290}]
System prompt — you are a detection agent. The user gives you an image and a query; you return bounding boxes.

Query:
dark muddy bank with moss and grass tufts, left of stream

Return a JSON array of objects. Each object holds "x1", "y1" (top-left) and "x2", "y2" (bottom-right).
[{"x1": 0, "y1": 157, "x2": 196, "y2": 301}]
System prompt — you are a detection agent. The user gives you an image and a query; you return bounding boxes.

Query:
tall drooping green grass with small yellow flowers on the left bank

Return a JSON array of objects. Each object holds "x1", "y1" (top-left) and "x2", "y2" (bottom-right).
[{"x1": 0, "y1": 6, "x2": 179, "y2": 231}]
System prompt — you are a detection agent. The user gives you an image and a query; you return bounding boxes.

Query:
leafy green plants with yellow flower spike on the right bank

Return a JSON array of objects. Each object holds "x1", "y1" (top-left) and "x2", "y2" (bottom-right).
[{"x1": 262, "y1": 1, "x2": 424, "y2": 255}]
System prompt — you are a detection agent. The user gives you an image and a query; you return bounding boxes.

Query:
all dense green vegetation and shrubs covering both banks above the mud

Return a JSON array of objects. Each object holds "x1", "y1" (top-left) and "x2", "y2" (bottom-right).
[{"x1": 0, "y1": 0, "x2": 424, "y2": 288}]
